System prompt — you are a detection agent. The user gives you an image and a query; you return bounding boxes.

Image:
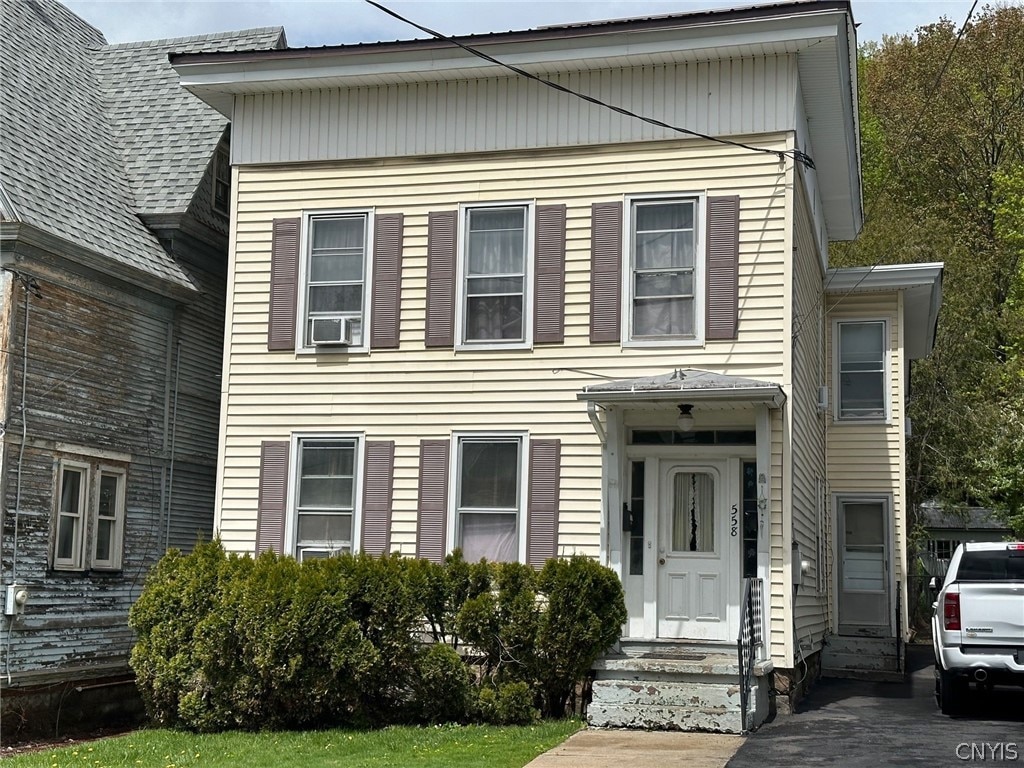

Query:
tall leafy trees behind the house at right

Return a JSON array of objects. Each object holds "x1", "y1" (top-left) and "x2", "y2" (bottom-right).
[{"x1": 831, "y1": 6, "x2": 1024, "y2": 536}]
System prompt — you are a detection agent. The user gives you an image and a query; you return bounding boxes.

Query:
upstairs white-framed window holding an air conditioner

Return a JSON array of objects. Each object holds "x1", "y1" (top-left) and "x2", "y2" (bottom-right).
[{"x1": 299, "y1": 211, "x2": 373, "y2": 351}]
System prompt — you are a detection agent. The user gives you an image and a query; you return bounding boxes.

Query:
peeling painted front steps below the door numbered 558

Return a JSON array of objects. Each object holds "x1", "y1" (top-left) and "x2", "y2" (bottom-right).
[{"x1": 588, "y1": 642, "x2": 768, "y2": 733}]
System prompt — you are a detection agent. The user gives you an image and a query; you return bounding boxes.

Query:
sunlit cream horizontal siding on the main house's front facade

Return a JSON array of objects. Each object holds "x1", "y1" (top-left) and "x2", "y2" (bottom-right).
[{"x1": 217, "y1": 134, "x2": 788, "y2": 555}]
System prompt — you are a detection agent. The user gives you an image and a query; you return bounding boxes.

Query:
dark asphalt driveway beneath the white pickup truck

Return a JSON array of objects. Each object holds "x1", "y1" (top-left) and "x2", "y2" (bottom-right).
[{"x1": 728, "y1": 646, "x2": 1024, "y2": 768}]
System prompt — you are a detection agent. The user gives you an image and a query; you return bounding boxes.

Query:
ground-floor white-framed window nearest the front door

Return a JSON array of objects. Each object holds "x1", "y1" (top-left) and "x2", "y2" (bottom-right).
[{"x1": 449, "y1": 433, "x2": 526, "y2": 562}]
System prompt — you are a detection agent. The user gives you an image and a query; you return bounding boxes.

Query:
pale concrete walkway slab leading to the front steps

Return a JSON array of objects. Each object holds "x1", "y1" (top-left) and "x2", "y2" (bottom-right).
[{"x1": 526, "y1": 729, "x2": 745, "y2": 768}]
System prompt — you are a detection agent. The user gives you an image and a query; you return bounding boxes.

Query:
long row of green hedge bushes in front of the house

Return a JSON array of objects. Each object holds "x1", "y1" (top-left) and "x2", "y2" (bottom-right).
[{"x1": 129, "y1": 542, "x2": 626, "y2": 731}]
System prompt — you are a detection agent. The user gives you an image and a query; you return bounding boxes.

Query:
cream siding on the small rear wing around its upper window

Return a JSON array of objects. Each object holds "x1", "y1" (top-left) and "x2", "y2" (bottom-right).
[{"x1": 825, "y1": 291, "x2": 908, "y2": 631}]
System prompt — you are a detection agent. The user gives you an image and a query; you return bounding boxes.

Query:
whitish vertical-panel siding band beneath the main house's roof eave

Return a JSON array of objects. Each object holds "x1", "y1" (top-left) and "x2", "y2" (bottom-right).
[{"x1": 231, "y1": 54, "x2": 798, "y2": 165}]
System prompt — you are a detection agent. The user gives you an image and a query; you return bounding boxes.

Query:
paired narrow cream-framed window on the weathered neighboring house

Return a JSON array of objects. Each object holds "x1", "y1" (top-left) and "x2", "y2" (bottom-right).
[{"x1": 52, "y1": 459, "x2": 127, "y2": 570}]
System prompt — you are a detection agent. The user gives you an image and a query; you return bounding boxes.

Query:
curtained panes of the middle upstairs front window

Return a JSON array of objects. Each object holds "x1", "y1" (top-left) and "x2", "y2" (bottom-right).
[{"x1": 465, "y1": 208, "x2": 526, "y2": 341}]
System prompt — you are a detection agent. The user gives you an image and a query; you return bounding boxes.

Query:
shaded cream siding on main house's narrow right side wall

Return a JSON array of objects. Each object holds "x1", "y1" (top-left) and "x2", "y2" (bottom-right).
[{"x1": 790, "y1": 183, "x2": 828, "y2": 654}]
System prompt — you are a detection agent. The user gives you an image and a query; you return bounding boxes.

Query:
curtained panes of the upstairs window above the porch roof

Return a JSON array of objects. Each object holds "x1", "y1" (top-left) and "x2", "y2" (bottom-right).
[{"x1": 633, "y1": 202, "x2": 694, "y2": 336}]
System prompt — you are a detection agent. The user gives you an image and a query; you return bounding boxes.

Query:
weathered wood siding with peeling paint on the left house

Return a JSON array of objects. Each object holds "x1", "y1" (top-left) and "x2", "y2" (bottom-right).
[{"x1": 0, "y1": 252, "x2": 223, "y2": 686}]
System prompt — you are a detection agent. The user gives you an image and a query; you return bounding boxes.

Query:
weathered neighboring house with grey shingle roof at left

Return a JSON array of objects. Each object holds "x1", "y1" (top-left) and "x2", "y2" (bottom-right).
[{"x1": 0, "y1": 0, "x2": 284, "y2": 737}]
